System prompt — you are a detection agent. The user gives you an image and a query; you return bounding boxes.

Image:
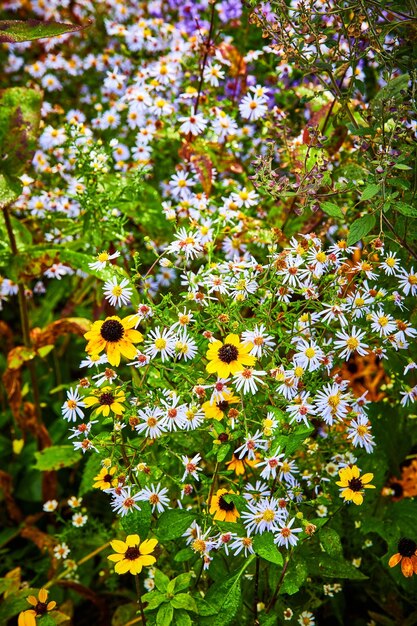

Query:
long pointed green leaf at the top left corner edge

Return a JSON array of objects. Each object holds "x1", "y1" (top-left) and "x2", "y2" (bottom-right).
[{"x1": 0, "y1": 20, "x2": 90, "y2": 43}]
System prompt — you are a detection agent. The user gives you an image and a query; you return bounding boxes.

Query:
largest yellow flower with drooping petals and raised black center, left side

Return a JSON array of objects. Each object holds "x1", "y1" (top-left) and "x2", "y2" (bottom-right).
[{"x1": 84, "y1": 315, "x2": 143, "y2": 366}]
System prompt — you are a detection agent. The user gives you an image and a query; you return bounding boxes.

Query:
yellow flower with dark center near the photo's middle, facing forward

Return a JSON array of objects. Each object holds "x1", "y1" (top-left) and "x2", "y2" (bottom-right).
[{"x1": 206, "y1": 334, "x2": 256, "y2": 378}]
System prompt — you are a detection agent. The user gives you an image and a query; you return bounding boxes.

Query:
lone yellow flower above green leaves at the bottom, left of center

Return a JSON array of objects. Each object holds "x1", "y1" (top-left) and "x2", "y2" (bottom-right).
[{"x1": 107, "y1": 535, "x2": 158, "y2": 574}]
